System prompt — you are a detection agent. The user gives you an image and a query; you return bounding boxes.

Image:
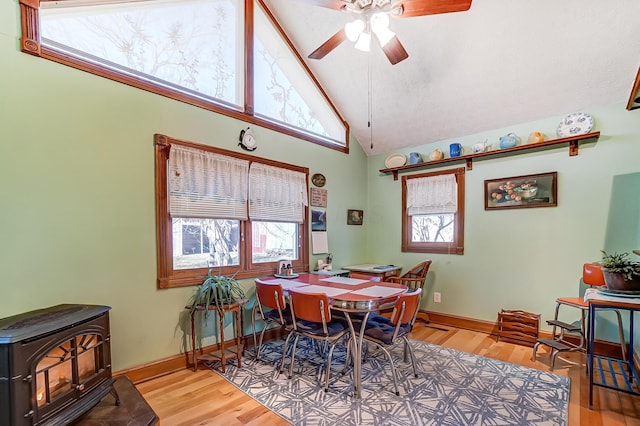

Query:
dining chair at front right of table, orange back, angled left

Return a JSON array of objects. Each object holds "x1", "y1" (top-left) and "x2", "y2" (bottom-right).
[{"x1": 354, "y1": 287, "x2": 422, "y2": 395}]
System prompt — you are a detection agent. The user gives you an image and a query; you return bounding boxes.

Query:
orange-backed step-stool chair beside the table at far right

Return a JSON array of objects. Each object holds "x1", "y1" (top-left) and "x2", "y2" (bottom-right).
[{"x1": 532, "y1": 263, "x2": 627, "y2": 371}]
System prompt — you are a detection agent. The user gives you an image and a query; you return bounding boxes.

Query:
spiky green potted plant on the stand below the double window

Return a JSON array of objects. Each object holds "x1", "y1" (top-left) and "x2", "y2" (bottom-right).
[{"x1": 189, "y1": 269, "x2": 247, "y2": 317}]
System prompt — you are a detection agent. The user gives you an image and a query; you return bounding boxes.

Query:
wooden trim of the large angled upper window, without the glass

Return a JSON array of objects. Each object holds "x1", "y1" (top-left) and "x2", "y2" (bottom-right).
[{"x1": 20, "y1": 0, "x2": 350, "y2": 154}]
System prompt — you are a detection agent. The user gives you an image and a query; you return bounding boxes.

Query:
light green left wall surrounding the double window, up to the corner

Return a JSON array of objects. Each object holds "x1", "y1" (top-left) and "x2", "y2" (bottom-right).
[{"x1": 0, "y1": 2, "x2": 367, "y2": 370}]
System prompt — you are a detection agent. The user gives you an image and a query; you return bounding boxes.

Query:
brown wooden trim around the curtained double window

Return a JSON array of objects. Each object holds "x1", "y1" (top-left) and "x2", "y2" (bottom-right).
[{"x1": 155, "y1": 134, "x2": 309, "y2": 289}]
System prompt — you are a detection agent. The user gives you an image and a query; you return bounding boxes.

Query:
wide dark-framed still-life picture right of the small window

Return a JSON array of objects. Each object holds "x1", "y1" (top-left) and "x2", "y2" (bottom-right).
[{"x1": 484, "y1": 172, "x2": 558, "y2": 210}]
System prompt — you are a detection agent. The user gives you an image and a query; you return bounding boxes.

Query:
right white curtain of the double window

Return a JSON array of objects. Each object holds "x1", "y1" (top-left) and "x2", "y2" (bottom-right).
[{"x1": 249, "y1": 163, "x2": 308, "y2": 223}]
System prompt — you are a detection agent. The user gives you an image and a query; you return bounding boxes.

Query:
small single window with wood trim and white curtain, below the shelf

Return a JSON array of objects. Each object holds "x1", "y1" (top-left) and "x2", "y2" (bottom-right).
[{"x1": 402, "y1": 168, "x2": 464, "y2": 254}]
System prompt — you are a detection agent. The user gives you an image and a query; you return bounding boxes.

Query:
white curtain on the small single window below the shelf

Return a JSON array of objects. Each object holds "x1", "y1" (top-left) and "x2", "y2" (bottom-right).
[{"x1": 407, "y1": 174, "x2": 458, "y2": 216}]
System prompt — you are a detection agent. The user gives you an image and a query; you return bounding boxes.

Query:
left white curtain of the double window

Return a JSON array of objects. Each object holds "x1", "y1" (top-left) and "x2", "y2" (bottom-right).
[{"x1": 168, "y1": 145, "x2": 249, "y2": 220}]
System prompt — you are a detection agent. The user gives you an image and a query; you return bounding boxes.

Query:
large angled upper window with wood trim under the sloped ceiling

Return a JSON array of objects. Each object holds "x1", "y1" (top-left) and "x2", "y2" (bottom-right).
[{"x1": 20, "y1": 0, "x2": 349, "y2": 152}]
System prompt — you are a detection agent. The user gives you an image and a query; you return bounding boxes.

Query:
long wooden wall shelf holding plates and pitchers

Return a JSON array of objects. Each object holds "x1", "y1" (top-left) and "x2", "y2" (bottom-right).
[{"x1": 380, "y1": 132, "x2": 600, "y2": 180}]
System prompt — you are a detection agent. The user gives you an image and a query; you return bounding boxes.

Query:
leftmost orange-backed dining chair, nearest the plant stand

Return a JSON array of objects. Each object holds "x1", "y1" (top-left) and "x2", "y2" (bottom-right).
[{"x1": 251, "y1": 279, "x2": 293, "y2": 359}]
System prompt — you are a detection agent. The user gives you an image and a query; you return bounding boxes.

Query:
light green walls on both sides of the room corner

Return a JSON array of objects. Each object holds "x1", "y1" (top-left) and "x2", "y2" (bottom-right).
[{"x1": 0, "y1": 2, "x2": 640, "y2": 370}]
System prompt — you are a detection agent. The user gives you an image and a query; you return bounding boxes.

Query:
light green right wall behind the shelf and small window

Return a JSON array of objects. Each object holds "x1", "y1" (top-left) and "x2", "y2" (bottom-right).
[{"x1": 365, "y1": 104, "x2": 640, "y2": 336}]
